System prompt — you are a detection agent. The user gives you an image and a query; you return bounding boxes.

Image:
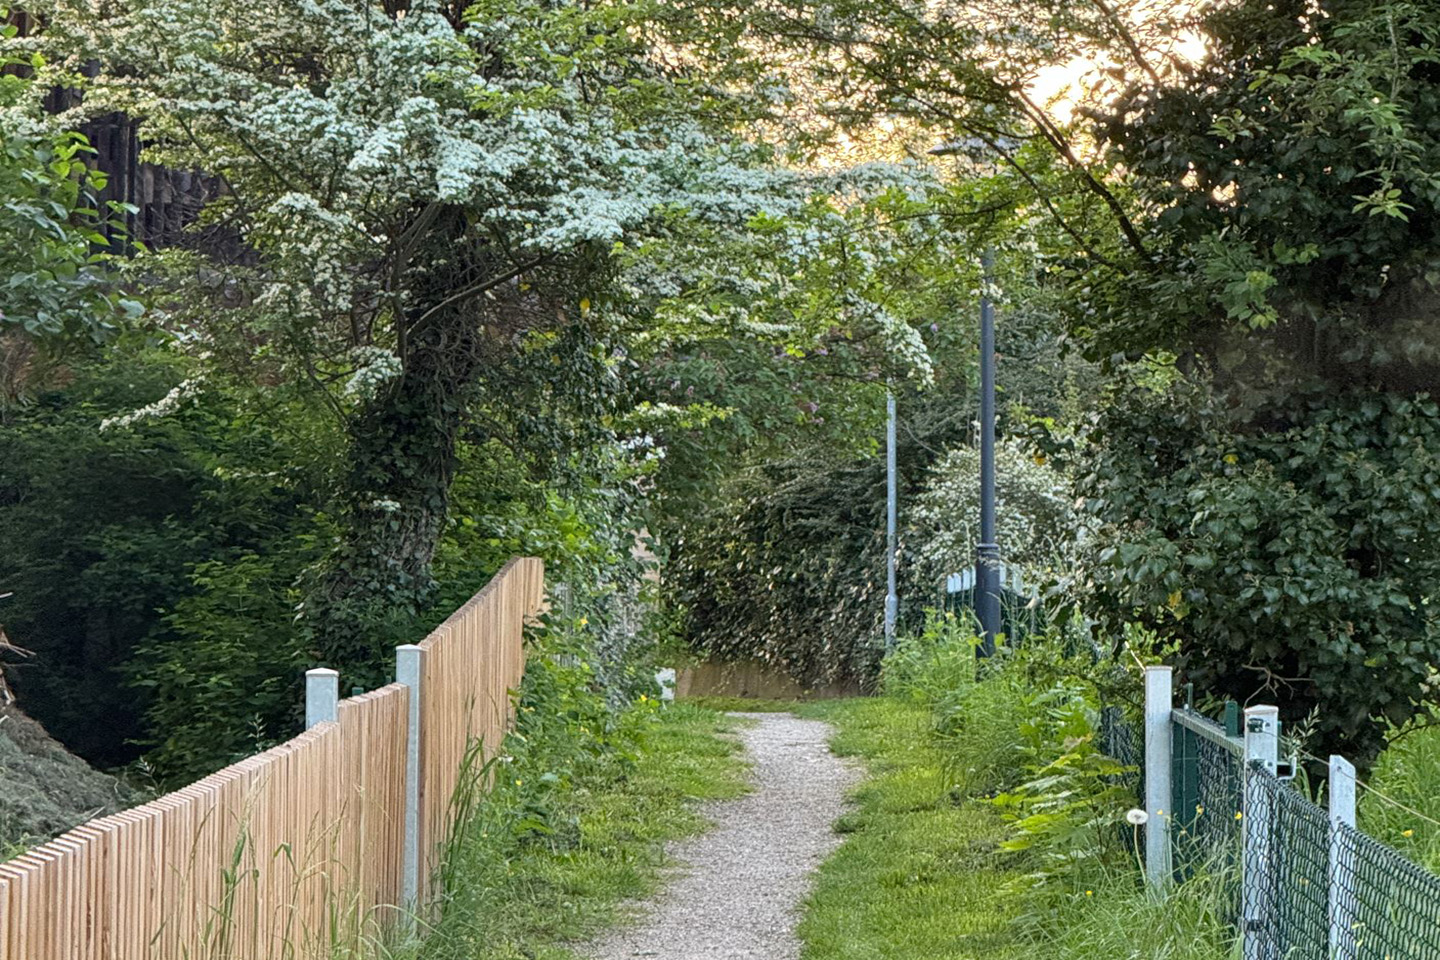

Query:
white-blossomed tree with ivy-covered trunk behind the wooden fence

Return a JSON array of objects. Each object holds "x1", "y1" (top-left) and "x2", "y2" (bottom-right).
[{"x1": 16, "y1": 0, "x2": 950, "y2": 682}]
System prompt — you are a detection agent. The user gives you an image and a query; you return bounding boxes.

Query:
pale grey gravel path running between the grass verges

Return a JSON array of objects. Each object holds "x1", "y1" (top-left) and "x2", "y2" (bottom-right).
[{"x1": 589, "y1": 714, "x2": 860, "y2": 960}]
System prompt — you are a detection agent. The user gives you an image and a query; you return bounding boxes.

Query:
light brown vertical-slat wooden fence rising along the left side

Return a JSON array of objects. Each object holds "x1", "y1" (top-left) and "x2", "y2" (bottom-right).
[{"x1": 0, "y1": 558, "x2": 544, "y2": 960}]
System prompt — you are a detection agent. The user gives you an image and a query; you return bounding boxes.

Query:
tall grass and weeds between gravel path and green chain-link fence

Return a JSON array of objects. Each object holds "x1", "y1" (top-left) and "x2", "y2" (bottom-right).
[{"x1": 801, "y1": 616, "x2": 1236, "y2": 960}]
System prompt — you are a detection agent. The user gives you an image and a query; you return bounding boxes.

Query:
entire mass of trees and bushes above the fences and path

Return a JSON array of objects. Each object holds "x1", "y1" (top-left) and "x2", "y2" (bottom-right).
[{"x1": 0, "y1": 0, "x2": 1440, "y2": 771}]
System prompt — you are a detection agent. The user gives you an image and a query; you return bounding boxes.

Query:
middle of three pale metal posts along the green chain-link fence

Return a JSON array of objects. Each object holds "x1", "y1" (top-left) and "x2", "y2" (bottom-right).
[{"x1": 1240, "y1": 707, "x2": 1280, "y2": 960}]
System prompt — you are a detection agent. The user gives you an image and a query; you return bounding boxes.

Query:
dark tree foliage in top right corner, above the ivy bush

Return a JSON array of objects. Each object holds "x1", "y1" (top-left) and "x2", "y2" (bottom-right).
[{"x1": 1081, "y1": 3, "x2": 1440, "y2": 374}]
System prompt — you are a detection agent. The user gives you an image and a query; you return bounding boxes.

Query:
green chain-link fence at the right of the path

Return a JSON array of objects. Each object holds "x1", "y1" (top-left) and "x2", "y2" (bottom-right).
[{"x1": 1099, "y1": 687, "x2": 1440, "y2": 960}]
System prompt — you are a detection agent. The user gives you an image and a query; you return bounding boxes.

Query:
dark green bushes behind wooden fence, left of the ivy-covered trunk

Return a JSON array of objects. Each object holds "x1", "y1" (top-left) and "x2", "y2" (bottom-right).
[{"x1": 0, "y1": 349, "x2": 330, "y2": 770}]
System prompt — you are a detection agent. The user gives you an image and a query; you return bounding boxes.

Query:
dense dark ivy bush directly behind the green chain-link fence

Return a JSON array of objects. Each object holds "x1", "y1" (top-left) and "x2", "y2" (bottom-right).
[{"x1": 1077, "y1": 383, "x2": 1440, "y2": 759}]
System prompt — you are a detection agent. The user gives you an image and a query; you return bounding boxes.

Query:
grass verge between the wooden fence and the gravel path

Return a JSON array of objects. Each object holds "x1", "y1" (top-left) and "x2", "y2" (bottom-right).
[{"x1": 419, "y1": 701, "x2": 747, "y2": 960}]
